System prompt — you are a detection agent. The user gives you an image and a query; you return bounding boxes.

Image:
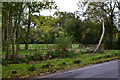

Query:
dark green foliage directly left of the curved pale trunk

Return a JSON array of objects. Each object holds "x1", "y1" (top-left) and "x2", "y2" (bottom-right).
[{"x1": 82, "y1": 21, "x2": 101, "y2": 44}]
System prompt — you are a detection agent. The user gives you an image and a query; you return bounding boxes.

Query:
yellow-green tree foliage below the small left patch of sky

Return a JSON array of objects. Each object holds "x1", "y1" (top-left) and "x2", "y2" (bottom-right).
[{"x1": 30, "y1": 15, "x2": 63, "y2": 43}]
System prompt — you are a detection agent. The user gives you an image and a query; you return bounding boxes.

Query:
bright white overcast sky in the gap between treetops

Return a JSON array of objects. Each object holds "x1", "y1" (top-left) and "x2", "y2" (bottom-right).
[{"x1": 41, "y1": 0, "x2": 78, "y2": 16}]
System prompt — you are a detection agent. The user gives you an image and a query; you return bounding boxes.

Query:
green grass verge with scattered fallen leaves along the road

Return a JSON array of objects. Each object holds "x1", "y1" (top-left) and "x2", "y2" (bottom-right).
[{"x1": 3, "y1": 50, "x2": 120, "y2": 78}]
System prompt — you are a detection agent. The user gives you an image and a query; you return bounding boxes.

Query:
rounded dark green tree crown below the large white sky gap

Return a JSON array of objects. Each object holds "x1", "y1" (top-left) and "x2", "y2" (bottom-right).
[{"x1": 63, "y1": 16, "x2": 84, "y2": 43}]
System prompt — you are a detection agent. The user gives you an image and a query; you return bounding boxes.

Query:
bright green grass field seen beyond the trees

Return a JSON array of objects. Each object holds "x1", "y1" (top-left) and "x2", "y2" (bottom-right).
[{"x1": 2, "y1": 44, "x2": 93, "y2": 55}]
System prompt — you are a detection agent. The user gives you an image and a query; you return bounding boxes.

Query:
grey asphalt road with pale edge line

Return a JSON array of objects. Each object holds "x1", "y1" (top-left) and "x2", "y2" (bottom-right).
[{"x1": 37, "y1": 60, "x2": 120, "y2": 80}]
